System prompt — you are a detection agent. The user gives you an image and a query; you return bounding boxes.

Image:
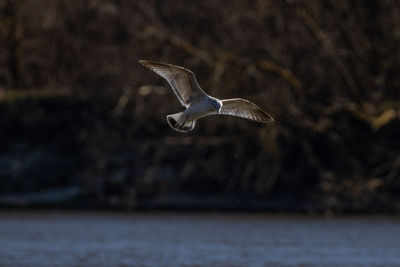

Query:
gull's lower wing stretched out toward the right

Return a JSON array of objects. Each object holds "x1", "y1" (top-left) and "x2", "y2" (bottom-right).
[{"x1": 219, "y1": 98, "x2": 274, "y2": 123}]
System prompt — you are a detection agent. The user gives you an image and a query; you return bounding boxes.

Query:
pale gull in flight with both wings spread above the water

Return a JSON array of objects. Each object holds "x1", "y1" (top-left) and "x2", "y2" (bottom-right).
[{"x1": 138, "y1": 60, "x2": 274, "y2": 133}]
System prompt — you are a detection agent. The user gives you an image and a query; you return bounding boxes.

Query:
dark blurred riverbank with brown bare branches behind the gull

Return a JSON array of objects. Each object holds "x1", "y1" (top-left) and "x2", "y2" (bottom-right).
[{"x1": 0, "y1": 0, "x2": 400, "y2": 213}]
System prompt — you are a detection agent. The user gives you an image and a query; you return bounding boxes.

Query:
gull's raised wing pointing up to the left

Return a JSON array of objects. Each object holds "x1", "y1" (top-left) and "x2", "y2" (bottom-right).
[{"x1": 139, "y1": 60, "x2": 206, "y2": 107}]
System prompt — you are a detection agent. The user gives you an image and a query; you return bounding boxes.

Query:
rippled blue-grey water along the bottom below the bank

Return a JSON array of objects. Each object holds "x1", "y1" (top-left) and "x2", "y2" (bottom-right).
[{"x1": 0, "y1": 212, "x2": 400, "y2": 266}]
